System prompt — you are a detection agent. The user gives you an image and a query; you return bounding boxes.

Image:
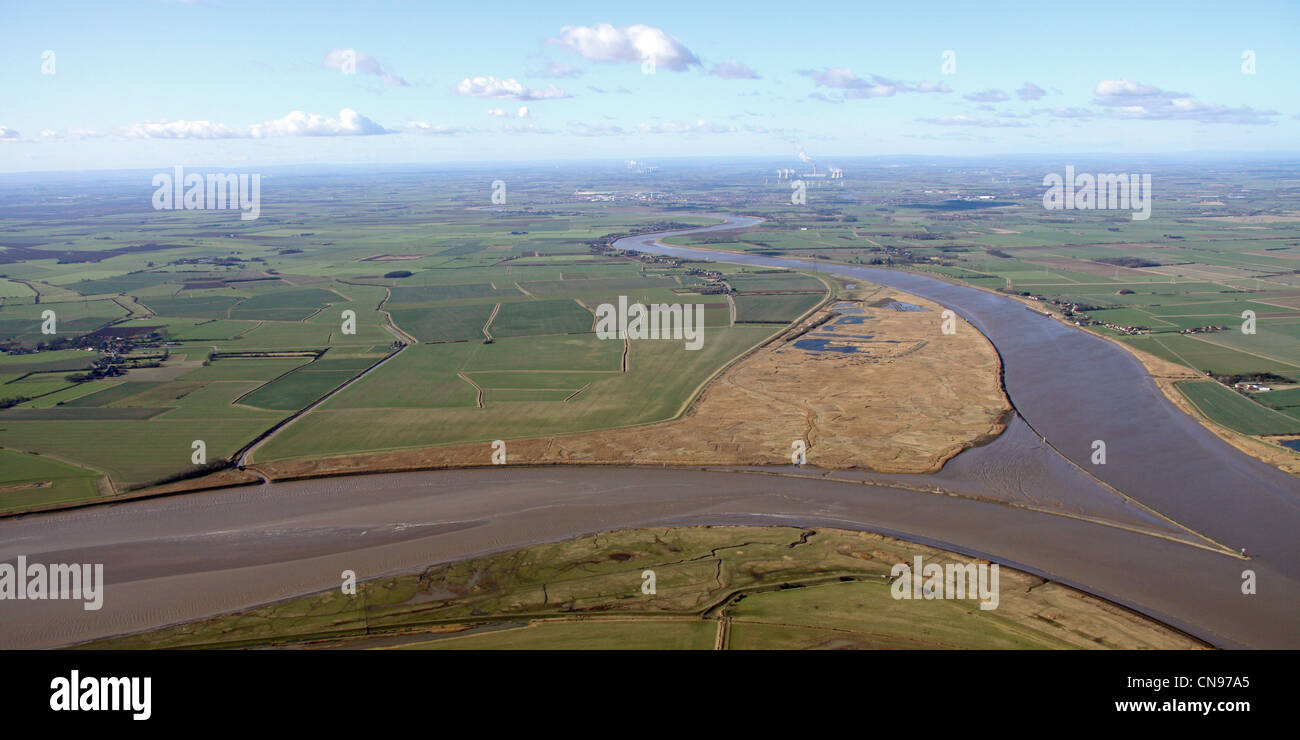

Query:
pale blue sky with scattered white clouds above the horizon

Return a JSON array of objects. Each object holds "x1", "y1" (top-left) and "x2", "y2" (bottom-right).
[{"x1": 0, "y1": 0, "x2": 1300, "y2": 172}]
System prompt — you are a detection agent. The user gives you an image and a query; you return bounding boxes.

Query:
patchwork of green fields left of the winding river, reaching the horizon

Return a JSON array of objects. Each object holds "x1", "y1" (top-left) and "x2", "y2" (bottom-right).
[{"x1": 0, "y1": 174, "x2": 824, "y2": 511}]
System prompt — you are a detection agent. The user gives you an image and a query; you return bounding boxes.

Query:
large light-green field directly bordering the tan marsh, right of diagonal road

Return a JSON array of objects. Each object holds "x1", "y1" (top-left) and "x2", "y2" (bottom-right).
[{"x1": 255, "y1": 326, "x2": 777, "y2": 462}]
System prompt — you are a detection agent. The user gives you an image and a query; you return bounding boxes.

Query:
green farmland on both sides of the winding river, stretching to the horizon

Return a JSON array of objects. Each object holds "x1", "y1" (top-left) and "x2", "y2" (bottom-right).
[{"x1": 0, "y1": 161, "x2": 1300, "y2": 507}]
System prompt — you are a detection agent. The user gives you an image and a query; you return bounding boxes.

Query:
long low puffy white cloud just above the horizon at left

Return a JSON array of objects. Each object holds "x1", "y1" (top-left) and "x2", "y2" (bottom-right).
[{"x1": 120, "y1": 108, "x2": 393, "y2": 139}]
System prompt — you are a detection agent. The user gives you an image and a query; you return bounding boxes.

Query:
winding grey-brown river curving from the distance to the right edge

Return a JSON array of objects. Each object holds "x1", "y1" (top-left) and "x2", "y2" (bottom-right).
[{"x1": 614, "y1": 215, "x2": 1300, "y2": 571}]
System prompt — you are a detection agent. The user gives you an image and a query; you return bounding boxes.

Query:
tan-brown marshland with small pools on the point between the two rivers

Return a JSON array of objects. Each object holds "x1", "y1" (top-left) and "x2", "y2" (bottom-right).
[{"x1": 250, "y1": 285, "x2": 1011, "y2": 480}]
